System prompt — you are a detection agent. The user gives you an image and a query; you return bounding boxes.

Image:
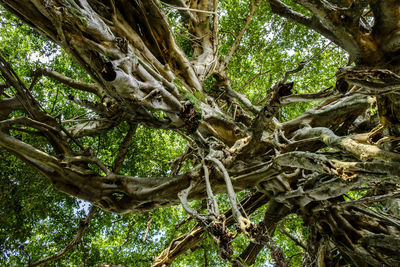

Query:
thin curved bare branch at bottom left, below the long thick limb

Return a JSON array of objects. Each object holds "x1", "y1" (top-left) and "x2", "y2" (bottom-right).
[{"x1": 28, "y1": 206, "x2": 98, "y2": 267}]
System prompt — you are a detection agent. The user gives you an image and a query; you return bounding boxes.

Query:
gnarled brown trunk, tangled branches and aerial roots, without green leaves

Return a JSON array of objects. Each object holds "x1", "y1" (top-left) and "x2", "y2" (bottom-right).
[{"x1": 0, "y1": 0, "x2": 400, "y2": 266}]
